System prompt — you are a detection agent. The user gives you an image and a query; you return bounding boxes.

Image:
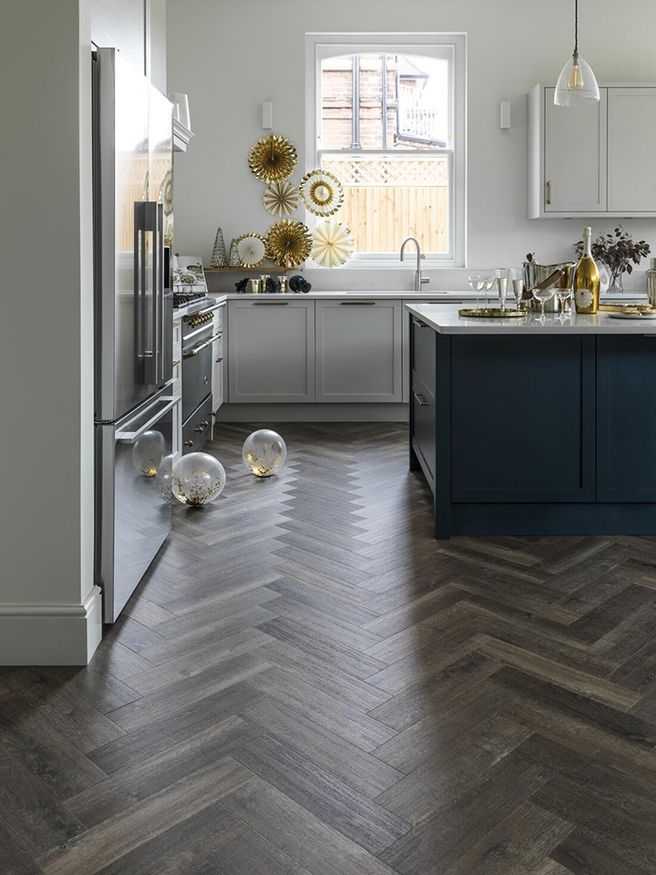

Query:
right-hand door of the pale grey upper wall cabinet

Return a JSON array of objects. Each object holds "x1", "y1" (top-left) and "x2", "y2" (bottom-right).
[{"x1": 608, "y1": 88, "x2": 656, "y2": 215}]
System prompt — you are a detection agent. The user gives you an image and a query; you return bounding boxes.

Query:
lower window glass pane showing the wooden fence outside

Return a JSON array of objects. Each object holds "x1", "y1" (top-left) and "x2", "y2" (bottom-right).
[{"x1": 321, "y1": 153, "x2": 449, "y2": 255}]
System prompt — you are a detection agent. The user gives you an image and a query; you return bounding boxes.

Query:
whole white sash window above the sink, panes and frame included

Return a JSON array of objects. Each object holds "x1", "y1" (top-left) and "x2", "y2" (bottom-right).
[{"x1": 306, "y1": 34, "x2": 466, "y2": 267}]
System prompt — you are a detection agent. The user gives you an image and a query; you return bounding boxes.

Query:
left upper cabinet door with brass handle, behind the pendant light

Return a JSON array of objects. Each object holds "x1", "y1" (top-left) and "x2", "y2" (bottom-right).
[{"x1": 544, "y1": 88, "x2": 608, "y2": 213}]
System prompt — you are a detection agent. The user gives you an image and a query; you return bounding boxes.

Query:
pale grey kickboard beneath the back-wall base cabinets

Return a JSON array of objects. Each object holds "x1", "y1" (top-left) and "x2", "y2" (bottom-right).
[{"x1": 216, "y1": 404, "x2": 408, "y2": 424}]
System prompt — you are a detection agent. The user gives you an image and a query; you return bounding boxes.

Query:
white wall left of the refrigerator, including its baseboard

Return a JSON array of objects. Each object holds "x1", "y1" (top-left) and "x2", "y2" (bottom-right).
[{"x1": 0, "y1": 0, "x2": 101, "y2": 664}]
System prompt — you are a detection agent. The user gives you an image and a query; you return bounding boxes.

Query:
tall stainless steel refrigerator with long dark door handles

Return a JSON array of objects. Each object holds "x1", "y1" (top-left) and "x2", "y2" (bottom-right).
[{"x1": 93, "y1": 48, "x2": 180, "y2": 623}]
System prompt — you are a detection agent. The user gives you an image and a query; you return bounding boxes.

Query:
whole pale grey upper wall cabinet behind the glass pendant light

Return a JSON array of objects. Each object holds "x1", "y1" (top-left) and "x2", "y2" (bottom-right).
[{"x1": 528, "y1": 85, "x2": 656, "y2": 219}]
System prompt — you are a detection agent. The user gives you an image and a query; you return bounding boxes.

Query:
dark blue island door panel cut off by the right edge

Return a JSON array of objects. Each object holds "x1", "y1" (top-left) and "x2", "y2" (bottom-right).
[{"x1": 597, "y1": 335, "x2": 656, "y2": 502}]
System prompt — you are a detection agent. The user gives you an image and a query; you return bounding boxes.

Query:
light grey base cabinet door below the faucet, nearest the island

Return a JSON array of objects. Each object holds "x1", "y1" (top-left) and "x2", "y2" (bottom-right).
[{"x1": 316, "y1": 300, "x2": 403, "y2": 402}]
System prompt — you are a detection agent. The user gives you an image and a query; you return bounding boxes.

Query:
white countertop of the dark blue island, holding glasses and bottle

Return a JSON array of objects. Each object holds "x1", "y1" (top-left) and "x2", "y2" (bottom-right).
[{"x1": 405, "y1": 302, "x2": 656, "y2": 335}]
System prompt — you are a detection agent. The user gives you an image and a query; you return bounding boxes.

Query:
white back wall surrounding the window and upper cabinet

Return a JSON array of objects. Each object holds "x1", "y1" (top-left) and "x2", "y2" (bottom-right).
[{"x1": 167, "y1": 0, "x2": 656, "y2": 289}]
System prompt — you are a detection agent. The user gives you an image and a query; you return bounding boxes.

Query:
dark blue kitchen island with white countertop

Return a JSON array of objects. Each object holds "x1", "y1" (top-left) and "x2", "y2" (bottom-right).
[{"x1": 406, "y1": 303, "x2": 656, "y2": 538}]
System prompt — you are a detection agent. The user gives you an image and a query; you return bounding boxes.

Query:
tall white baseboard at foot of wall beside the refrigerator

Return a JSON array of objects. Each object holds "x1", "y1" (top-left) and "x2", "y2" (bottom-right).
[{"x1": 0, "y1": 586, "x2": 102, "y2": 665}]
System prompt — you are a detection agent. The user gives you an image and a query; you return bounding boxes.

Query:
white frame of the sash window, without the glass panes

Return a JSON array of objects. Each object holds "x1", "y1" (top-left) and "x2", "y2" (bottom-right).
[{"x1": 305, "y1": 33, "x2": 467, "y2": 270}]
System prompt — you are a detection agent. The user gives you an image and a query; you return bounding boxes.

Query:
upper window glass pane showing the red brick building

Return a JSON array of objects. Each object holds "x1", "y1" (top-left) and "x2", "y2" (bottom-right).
[{"x1": 321, "y1": 54, "x2": 450, "y2": 150}]
